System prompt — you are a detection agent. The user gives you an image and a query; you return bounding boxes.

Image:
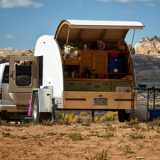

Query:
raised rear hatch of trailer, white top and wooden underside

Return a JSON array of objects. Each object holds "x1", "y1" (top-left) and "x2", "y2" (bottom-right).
[{"x1": 55, "y1": 20, "x2": 144, "y2": 42}]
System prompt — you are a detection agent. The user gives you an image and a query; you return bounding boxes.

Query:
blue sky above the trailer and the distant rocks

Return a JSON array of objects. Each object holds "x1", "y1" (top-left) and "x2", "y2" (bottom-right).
[{"x1": 0, "y1": 0, "x2": 160, "y2": 48}]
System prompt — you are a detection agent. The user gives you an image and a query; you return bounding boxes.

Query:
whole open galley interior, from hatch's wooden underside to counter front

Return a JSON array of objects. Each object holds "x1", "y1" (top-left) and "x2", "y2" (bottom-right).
[{"x1": 57, "y1": 20, "x2": 134, "y2": 92}]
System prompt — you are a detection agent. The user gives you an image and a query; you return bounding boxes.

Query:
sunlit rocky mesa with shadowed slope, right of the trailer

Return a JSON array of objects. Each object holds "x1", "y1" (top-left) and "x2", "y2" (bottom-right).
[{"x1": 134, "y1": 36, "x2": 160, "y2": 87}]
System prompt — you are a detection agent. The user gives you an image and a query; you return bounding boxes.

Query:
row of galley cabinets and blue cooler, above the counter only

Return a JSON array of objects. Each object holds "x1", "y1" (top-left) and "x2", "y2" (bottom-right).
[{"x1": 63, "y1": 49, "x2": 129, "y2": 79}]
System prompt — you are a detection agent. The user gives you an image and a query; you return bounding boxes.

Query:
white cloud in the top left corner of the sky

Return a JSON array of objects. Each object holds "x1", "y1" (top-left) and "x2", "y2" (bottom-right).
[{"x1": 0, "y1": 0, "x2": 43, "y2": 8}]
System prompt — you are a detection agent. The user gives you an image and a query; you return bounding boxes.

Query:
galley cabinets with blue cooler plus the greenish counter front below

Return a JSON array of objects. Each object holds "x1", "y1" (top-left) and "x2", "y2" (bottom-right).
[{"x1": 63, "y1": 49, "x2": 132, "y2": 92}]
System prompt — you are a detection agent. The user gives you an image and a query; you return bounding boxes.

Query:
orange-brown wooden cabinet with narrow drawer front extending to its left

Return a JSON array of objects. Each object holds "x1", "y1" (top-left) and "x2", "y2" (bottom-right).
[{"x1": 64, "y1": 49, "x2": 108, "y2": 78}]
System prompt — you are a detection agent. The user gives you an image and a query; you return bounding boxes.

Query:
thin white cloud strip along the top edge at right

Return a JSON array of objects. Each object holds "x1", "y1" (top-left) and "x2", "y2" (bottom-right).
[{"x1": 97, "y1": 0, "x2": 159, "y2": 7}]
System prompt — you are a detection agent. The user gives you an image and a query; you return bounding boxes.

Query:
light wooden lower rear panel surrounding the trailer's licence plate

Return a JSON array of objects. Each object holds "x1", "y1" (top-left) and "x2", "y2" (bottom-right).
[{"x1": 64, "y1": 91, "x2": 132, "y2": 109}]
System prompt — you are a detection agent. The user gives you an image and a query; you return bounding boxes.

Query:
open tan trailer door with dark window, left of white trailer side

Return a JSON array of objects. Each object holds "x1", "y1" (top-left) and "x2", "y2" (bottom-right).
[{"x1": 9, "y1": 57, "x2": 39, "y2": 93}]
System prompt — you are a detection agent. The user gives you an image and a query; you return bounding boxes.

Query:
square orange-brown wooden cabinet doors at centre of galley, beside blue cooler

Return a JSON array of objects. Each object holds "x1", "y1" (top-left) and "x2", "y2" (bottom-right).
[{"x1": 80, "y1": 49, "x2": 108, "y2": 79}]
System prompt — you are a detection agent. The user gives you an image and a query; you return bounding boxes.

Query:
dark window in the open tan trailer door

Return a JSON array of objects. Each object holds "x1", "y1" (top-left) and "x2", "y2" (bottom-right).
[{"x1": 16, "y1": 61, "x2": 32, "y2": 86}]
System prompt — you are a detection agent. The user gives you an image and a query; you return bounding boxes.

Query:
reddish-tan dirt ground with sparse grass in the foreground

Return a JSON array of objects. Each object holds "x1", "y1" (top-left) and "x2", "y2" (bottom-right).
[{"x1": 0, "y1": 121, "x2": 160, "y2": 160}]
